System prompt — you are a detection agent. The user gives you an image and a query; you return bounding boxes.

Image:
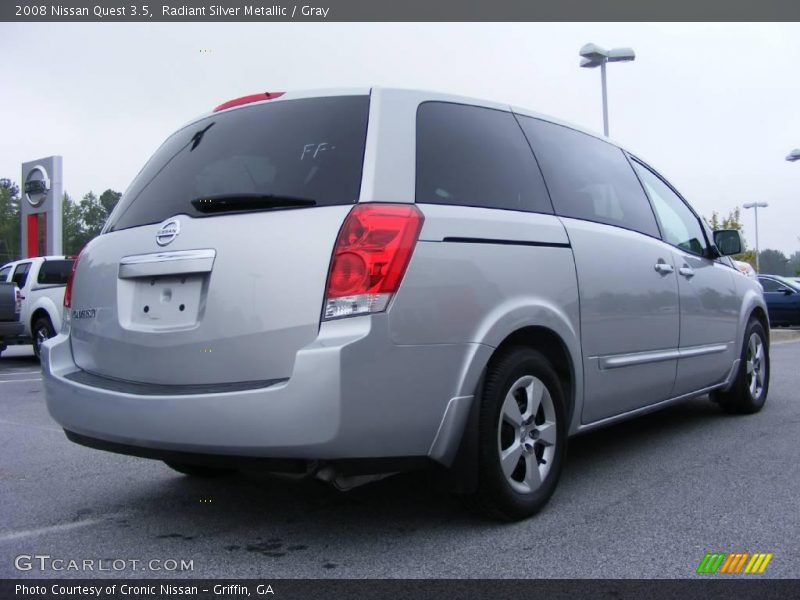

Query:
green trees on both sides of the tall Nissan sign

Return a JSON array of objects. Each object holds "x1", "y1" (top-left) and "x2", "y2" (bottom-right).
[{"x1": 0, "y1": 179, "x2": 122, "y2": 265}]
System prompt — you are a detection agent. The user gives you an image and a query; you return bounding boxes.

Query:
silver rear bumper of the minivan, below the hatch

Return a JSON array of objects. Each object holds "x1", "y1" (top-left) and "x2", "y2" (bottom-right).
[{"x1": 42, "y1": 315, "x2": 486, "y2": 463}]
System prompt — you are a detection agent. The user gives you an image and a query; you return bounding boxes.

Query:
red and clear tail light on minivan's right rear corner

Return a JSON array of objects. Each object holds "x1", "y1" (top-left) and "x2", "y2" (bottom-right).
[{"x1": 324, "y1": 203, "x2": 424, "y2": 320}]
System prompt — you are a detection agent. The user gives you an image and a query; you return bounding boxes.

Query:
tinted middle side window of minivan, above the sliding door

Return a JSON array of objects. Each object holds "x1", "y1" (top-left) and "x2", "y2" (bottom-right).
[{"x1": 519, "y1": 116, "x2": 658, "y2": 237}]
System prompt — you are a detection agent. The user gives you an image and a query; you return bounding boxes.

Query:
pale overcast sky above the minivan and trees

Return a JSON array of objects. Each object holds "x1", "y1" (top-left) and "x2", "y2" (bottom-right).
[{"x1": 0, "y1": 23, "x2": 800, "y2": 255}]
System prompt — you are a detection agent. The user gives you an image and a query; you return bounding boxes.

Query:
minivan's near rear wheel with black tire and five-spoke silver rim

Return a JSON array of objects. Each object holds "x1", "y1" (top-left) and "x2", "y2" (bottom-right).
[{"x1": 465, "y1": 347, "x2": 567, "y2": 521}]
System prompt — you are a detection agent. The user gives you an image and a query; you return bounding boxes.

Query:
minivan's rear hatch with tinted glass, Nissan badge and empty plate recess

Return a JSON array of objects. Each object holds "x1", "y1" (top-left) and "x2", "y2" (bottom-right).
[{"x1": 70, "y1": 95, "x2": 369, "y2": 385}]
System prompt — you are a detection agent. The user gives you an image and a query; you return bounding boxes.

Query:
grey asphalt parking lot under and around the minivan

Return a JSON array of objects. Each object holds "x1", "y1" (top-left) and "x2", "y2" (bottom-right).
[{"x1": 0, "y1": 342, "x2": 800, "y2": 578}]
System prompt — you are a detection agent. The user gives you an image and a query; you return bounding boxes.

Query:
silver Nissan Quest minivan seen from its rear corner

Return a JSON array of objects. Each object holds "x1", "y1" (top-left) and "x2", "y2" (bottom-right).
[{"x1": 42, "y1": 88, "x2": 770, "y2": 519}]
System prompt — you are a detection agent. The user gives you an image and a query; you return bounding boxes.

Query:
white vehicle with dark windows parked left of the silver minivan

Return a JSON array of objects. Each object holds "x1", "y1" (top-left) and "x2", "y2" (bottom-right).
[{"x1": 0, "y1": 256, "x2": 75, "y2": 357}]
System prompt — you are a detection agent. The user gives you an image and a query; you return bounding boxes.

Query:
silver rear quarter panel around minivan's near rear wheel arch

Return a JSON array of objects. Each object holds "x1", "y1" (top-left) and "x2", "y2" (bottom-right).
[{"x1": 389, "y1": 204, "x2": 583, "y2": 432}]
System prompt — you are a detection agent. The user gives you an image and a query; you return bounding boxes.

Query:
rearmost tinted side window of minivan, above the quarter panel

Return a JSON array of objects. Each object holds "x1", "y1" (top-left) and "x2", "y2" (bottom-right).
[{"x1": 416, "y1": 102, "x2": 553, "y2": 214}]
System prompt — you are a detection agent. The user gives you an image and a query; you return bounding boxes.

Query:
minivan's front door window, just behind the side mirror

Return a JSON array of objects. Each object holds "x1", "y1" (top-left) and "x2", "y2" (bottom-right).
[{"x1": 633, "y1": 161, "x2": 707, "y2": 255}]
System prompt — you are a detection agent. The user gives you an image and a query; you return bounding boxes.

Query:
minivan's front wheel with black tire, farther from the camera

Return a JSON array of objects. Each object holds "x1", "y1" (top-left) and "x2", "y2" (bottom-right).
[{"x1": 711, "y1": 319, "x2": 770, "y2": 415}]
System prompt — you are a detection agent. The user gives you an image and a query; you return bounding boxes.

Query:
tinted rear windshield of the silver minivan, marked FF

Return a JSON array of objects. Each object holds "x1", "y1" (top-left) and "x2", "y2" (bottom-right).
[{"x1": 107, "y1": 96, "x2": 369, "y2": 231}]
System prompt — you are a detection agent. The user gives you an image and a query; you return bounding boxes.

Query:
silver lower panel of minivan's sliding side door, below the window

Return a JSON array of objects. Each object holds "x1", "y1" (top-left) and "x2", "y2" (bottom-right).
[{"x1": 562, "y1": 218, "x2": 679, "y2": 423}]
